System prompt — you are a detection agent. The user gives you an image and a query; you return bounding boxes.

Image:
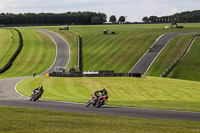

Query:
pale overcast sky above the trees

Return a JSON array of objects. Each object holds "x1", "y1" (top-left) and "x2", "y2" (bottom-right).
[{"x1": 0, "y1": 0, "x2": 200, "y2": 22}]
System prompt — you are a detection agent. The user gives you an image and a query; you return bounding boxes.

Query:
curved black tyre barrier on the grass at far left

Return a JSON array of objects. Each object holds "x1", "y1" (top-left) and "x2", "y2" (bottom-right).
[{"x1": 0, "y1": 29, "x2": 23, "y2": 74}]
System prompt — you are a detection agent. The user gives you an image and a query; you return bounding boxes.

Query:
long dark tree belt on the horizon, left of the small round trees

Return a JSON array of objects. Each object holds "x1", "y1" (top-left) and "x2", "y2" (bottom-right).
[{"x1": 0, "y1": 12, "x2": 107, "y2": 25}]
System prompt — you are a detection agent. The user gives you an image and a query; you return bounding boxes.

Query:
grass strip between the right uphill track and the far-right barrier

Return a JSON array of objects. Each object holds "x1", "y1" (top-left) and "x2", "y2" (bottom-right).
[{"x1": 146, "y1": 33, "x2": 200, "y2": 77}]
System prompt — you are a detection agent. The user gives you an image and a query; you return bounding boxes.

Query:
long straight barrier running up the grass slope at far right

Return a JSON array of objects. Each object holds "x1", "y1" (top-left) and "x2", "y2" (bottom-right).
[{"x1": 160, "y1": 34, "x2": 200, "y2": 77}]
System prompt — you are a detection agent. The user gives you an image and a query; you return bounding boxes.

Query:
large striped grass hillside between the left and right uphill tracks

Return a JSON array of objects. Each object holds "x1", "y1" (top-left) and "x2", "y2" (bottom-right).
[{"x1": 31, "y1": 24, "x2": 200, "y2": 72}]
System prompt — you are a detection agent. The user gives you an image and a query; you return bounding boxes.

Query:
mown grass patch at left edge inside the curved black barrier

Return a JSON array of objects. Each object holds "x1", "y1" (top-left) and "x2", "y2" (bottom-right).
[{"x1": 0, "y1": 29, "x2": 19, "y2": 69}]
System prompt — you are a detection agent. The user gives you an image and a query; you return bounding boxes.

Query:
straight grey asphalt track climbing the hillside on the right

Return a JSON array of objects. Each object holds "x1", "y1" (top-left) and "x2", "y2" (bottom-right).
[{"x1": 129, "y1": 32, "x2": 191, "y2": 75}]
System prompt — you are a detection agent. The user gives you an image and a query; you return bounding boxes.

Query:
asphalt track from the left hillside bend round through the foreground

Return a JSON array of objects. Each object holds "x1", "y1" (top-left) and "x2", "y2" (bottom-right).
[{"x1": 0, "y1": 30, "x2": 200, "y2": 121}]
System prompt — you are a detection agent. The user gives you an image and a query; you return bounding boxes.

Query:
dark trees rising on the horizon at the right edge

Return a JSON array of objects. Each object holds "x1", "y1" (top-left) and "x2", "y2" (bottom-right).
[{"x1": 142, "y1": 10, "x2": 200, "y2": 23}]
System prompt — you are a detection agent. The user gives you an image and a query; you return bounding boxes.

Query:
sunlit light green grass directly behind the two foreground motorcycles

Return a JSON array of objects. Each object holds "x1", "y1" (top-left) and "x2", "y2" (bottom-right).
[{"x1": 17, "y1": 77, "x2": 200, "y2": 112}]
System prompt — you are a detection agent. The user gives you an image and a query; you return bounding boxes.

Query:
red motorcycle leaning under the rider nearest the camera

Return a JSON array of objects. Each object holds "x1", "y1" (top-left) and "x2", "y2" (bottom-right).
[{"x1": 85, "y1": 94, "x2": 108, "y2": 108}]
